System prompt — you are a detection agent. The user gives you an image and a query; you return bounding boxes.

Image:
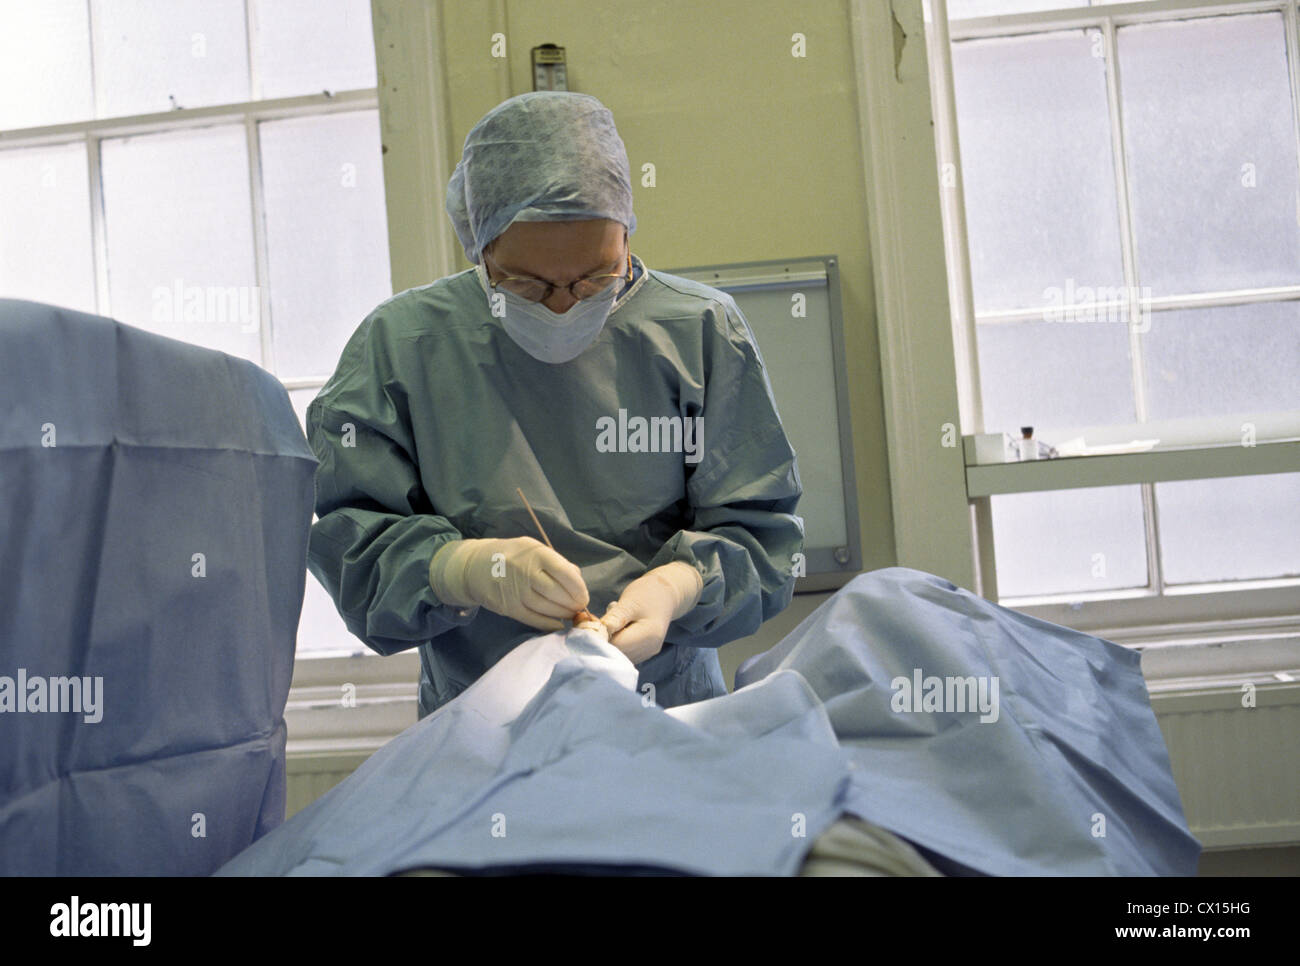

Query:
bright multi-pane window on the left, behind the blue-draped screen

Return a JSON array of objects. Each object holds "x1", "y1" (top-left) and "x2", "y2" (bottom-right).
[{"x1": 0, "y1": 0, "x2": 391, "y2": 654}]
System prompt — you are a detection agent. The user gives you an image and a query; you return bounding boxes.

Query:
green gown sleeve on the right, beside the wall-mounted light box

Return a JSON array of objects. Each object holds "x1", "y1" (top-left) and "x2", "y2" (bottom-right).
[{"x1": 649, "y1": 294, "x2": 803, "y2": 647}]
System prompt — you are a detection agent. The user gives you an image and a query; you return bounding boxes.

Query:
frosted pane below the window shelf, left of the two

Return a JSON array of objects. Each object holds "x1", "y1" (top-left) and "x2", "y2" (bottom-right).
[{"x1": 989, "y1": 486, "x2": 1148, "y2": 598}]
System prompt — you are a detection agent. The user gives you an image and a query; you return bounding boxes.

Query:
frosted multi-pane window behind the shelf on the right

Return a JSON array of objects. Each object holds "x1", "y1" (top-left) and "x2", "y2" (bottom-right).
[{"x1": 935, "y1": 0, "x2": 1300, "y2": 614}]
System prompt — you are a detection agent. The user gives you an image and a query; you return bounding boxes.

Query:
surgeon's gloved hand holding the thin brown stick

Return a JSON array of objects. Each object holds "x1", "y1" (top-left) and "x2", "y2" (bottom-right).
[{"x1": 429, "y1": 537, "x2": 590, "y2": 631}]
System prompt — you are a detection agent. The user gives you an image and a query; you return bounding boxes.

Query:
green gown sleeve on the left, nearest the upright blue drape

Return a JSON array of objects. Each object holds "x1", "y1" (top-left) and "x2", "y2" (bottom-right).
[{"x1": 307, "y1": 315, "x2": 477, "y2": 654}]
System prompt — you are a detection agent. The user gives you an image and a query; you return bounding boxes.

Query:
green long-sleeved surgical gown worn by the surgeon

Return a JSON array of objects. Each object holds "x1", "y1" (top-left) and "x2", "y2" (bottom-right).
[{"x1": 307, "y1": 259, "x2": 803, "y2": 718}]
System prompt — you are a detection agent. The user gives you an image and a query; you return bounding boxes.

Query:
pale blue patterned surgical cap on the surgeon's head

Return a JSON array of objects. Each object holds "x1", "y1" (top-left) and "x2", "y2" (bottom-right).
[{"x1": 447, "y1": 91, "x2": 637, "y2": 264}]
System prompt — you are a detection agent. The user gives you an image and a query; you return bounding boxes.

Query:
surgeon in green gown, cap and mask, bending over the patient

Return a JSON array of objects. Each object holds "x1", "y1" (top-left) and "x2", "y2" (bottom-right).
[{"x1": 307, "y1": 91, "x2": 803, "y2": 718}]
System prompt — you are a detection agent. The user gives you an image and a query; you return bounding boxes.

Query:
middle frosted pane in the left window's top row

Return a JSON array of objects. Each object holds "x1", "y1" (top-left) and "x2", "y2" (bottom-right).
[{"x1": 94, "y1": 0, "x2": 248, "y2": 117}]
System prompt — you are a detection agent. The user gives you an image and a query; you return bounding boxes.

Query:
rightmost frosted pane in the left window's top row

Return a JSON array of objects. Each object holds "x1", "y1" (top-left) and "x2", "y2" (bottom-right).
[{"x1": 252, "y1": 0, "x2": 376, "y2": 98}]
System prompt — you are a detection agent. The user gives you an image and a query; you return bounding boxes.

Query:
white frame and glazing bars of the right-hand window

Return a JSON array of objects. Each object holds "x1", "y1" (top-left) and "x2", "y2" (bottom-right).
[{"x1": 909, "y1": 0, "x2": 1300, "y2": 642}]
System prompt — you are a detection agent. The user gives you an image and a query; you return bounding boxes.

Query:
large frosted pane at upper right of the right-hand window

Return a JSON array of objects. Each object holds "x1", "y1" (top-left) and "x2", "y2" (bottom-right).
[{"x1": 1118, "y1": 13, "x2": 1300, "y2": 295}]
